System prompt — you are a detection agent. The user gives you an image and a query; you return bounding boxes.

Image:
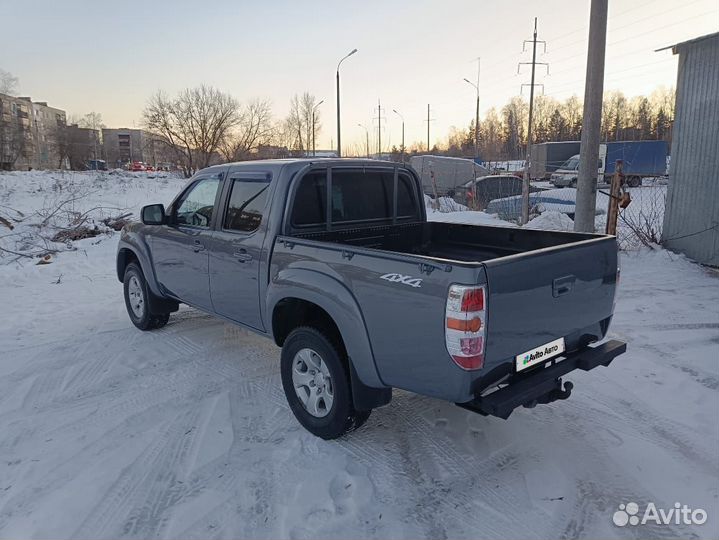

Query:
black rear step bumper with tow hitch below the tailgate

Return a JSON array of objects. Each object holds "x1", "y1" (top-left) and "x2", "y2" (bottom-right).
[{"x1": 457, "y1": 340, "x2": 627, "y2": 419}]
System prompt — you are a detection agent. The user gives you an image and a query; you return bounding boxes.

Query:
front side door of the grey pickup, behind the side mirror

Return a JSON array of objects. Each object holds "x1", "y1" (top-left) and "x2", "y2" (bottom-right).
[{"x1": 152, "y1": 173, "x2": 221, "y2": 310}]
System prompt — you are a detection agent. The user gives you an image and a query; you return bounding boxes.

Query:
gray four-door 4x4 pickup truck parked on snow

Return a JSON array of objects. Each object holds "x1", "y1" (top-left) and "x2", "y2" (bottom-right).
[{"x1": 117, "y1": 159, "x2": 626, "y2": 439}]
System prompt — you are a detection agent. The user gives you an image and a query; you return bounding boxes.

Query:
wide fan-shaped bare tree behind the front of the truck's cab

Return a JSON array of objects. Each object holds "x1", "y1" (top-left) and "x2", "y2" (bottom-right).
[{"x1": 143, "y1": 85, "x2": 240, "y2": 176}]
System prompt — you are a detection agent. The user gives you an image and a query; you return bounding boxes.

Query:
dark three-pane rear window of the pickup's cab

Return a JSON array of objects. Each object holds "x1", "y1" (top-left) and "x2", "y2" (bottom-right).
[{"x1": 292, "y1": 169, "x2": 418, "y2": 226}]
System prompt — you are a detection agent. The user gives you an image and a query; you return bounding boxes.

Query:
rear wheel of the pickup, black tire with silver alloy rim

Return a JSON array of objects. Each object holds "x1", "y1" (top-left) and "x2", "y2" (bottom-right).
[{"x1": 280, "y1": 326, "x2": 372, "y2": 439}]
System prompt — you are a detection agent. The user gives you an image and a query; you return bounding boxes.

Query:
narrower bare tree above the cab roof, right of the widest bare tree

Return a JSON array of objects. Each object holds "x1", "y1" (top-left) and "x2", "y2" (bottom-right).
[{"x1": 220, "y1": 99, "x2": 274, "y2": 161}]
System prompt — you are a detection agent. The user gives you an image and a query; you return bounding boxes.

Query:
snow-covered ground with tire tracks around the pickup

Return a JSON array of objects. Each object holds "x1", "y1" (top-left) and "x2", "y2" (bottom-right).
[{"x1": 0, "y1": 173, "x2": 719, "y2": 540}]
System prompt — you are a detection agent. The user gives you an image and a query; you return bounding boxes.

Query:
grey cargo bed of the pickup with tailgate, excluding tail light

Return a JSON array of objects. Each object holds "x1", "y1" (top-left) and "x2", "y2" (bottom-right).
[{"x1": 273, "y1": 214, "x2": 617, "y2": 403}]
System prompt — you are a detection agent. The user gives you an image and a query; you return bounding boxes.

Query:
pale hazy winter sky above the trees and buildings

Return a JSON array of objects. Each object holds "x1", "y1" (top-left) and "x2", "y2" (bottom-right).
[{"x1": 0, "y1": 0, "x2": 719, "y2": 150}]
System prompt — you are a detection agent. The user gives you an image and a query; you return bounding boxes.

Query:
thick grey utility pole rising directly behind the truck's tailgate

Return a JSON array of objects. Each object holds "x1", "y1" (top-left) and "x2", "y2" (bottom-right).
[{"x1": 574, "y1": 0, "x2": 608, "y2": 232}]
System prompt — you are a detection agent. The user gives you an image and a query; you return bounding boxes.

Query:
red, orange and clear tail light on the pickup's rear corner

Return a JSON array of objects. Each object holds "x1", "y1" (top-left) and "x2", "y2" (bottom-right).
[{"x1": 444, "y1": 285, "x2": 487, "y2": 370}]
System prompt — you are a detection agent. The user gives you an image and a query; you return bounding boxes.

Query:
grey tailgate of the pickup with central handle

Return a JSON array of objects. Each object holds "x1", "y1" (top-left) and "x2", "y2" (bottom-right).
[{"x1": 484, "y1": 237, "x2": 617, "y2": 371}]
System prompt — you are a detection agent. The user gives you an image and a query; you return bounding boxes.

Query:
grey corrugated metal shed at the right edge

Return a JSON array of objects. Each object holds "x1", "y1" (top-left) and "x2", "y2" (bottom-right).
[{"x1": 660, "y1": 32, "x2": 719, "y2": 266}]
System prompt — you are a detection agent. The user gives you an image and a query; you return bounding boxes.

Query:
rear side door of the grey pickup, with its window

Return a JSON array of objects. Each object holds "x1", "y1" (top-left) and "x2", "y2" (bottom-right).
[{"x1": 210, "y1": 173, "x2": 270, "y2": 330}]
